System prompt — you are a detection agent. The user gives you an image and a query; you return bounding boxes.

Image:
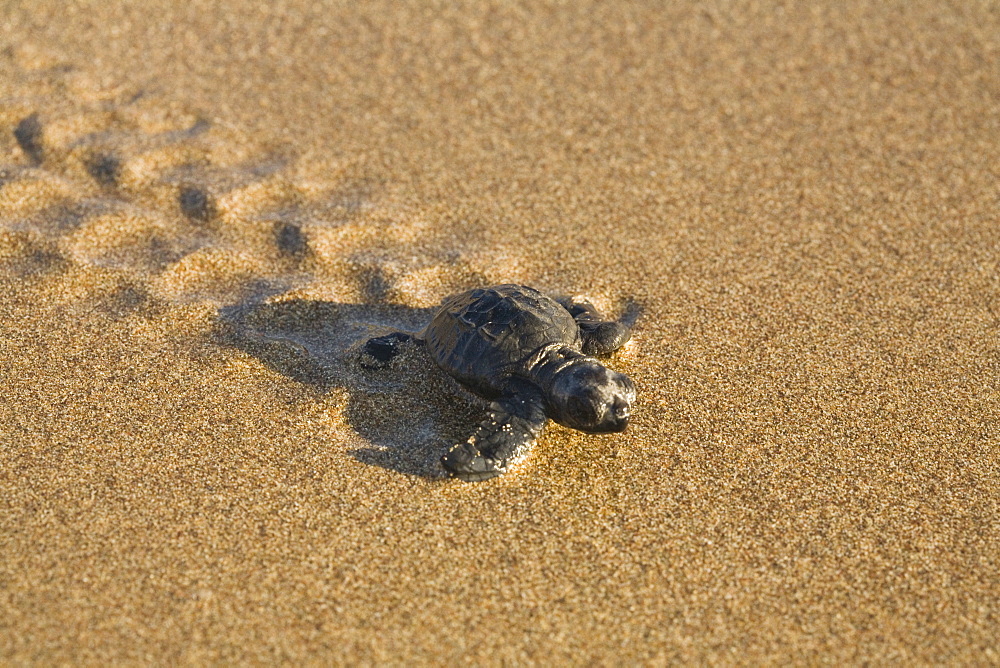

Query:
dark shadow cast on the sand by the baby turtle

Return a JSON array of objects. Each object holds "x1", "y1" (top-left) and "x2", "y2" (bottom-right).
[{"x1": 219, "y1": 300, "x2": 486, "y2": 478}]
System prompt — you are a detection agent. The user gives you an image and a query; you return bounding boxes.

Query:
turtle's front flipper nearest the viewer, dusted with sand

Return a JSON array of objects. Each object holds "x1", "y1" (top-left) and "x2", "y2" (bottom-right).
[{"x1": 441, "y1": 388, "x2": 546, "y2": 482}]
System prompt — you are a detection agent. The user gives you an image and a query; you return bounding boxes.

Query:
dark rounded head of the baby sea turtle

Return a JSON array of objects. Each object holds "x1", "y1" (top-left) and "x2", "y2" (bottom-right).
[{"x1": 548, "y1": 358, "x2": 635, "y2": 434}]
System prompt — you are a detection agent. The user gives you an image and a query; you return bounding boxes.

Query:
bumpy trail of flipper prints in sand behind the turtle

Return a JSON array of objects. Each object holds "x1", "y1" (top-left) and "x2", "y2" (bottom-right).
[{"x1": 0, "y1": 53, "x2": 508, "y2": 307}]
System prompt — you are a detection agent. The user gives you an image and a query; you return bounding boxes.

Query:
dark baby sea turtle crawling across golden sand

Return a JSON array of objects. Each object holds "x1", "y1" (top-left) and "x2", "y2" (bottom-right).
[{"x1": 362, "y1": 285, "x2": 635, "y2": 481}]
